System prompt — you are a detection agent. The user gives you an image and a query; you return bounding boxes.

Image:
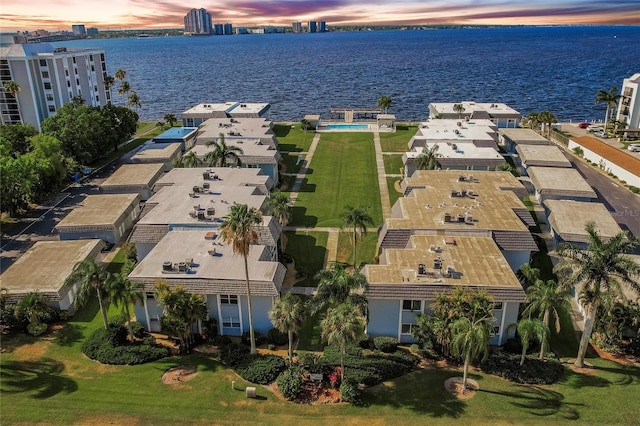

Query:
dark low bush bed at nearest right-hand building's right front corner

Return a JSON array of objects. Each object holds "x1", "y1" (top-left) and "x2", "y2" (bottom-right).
[{"x1": 480, "y1": 350, "x2": 564, "y2": 385}]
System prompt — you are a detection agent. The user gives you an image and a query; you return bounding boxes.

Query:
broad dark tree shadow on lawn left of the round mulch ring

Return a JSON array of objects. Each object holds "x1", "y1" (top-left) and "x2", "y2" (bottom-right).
[{"x1": 363, "y1": 370, "x2": 467, "y2": 419}]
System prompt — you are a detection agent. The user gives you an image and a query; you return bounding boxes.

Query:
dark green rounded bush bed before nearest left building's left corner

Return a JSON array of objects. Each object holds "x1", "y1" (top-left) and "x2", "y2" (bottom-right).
[{"x1": 82, "y1": 325, "x2": 169, "y2": 365}]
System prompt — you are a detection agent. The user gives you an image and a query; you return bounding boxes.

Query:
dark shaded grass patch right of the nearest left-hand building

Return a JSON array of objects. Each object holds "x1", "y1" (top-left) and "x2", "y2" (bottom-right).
[{"x1": 285, "y1": 231, "x2": 328, "y2": 287}]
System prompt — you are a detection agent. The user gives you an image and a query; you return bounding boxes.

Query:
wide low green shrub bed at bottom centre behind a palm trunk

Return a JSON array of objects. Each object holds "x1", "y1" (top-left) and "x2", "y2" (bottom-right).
[{"x1": 319, "y1": 346, "x2": 418, "y2": 386}]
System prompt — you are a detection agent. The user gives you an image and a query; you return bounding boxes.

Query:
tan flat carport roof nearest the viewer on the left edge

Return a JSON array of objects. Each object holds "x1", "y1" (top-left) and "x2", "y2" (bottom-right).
[{"x1": 0, "y1": 239, "x2": 104, "y2": 294}]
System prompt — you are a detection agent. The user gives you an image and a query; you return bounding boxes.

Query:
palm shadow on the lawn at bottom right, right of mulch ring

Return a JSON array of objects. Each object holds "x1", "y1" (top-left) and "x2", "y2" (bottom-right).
[{"x1": 478, "y1": 385, "x2": 584, "y2": 420}]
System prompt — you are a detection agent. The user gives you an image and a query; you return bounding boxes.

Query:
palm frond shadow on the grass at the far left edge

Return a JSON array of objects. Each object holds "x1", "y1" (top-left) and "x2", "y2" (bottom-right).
[{"x1": 0, "y1": 358, "x2": 78, "y2": 399}]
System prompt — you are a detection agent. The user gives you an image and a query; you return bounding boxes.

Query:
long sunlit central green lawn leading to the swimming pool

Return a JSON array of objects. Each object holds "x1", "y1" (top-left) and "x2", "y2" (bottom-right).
[{"x1": 291, "y1": 133, "x2": 382, "y2": 227}]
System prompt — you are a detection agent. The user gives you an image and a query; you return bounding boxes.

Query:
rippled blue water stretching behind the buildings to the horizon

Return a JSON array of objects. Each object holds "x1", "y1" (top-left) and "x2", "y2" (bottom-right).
[{"x1": 55, "y1": 27, "x2": 640, "y2": 121}]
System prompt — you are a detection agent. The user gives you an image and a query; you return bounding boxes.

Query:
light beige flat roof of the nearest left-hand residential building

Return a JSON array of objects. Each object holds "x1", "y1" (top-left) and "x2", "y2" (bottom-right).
[{"x1": 129, "y1": 230, "x2": 286, "y2": 296}]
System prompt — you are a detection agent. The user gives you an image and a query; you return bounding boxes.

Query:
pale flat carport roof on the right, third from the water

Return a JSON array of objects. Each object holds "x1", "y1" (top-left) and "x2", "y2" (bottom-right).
[{"x1": 527, "y1": 167, "x2": 597, "y2": 198}]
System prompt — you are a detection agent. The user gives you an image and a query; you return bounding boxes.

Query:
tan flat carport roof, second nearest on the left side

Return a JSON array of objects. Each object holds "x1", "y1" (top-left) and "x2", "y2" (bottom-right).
[{"x1": 56, "y1": 194, "x2": 140, "y2": 229}]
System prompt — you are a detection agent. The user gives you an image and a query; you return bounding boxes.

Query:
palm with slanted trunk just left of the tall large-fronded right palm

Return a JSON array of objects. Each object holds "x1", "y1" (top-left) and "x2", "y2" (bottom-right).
[{"x1": 521, "y1": 278, "x2": 571, "y2": 359}]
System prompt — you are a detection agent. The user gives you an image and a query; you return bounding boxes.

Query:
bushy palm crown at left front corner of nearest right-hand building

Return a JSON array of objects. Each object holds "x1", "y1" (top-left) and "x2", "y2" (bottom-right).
[{"x1": 309, "y1": 263, "x2": 368, "y2": 317}]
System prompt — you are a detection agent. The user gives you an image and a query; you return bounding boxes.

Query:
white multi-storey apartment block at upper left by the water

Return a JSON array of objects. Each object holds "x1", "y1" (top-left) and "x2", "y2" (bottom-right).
[{"x1": 0, "y1": 43, "x2": 111, "y2": 130}]
